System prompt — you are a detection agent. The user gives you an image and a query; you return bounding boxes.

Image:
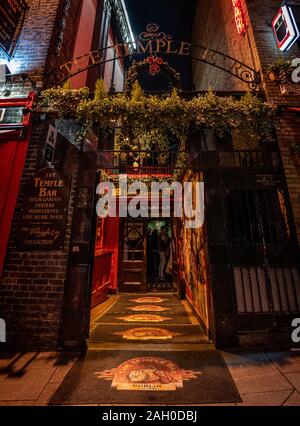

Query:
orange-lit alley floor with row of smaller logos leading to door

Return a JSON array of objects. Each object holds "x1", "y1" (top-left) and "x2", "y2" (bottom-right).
[{"x1": 89, "y1": 293, "x2": 208, "y2": 346}]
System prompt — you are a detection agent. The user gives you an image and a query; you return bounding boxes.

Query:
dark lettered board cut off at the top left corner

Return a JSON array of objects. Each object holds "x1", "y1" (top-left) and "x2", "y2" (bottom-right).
[{"x1": 0, "y1": 0, "x2": 27, "y2": 54}]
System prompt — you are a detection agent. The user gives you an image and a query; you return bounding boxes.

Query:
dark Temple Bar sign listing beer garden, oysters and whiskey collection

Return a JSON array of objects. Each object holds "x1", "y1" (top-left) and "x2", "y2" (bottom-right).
[{"x1": 17, "y1": 168, "x2": 72, "y2": 251}]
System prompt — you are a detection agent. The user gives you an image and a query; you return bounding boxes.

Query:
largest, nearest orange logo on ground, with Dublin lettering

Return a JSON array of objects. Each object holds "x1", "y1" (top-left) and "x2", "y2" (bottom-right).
[{"x1": 94, "y1": 357, "x2": 202, "y2": 392}]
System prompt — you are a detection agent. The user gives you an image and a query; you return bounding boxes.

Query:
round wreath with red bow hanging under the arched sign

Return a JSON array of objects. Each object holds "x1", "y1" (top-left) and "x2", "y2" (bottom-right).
[{"x1": 125, "y1": 56, "x2": 180, "y2": 95}]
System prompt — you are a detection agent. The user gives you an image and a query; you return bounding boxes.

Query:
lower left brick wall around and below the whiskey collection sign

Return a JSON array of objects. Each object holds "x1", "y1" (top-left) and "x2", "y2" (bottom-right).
[{"x1": 0, "y1": 123, "x2": 78, "y2": 350}]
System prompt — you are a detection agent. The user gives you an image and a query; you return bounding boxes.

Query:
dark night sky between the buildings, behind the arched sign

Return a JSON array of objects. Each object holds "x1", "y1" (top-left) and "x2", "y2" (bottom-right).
[{"x1": 125, "y1": 0, "x2": 195, "y2": 90}]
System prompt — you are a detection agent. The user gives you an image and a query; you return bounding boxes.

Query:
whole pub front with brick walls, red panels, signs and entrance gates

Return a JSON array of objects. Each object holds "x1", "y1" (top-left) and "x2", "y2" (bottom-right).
[{"x1": 0, "y1": 0, "x2": 300, "y2": 350}]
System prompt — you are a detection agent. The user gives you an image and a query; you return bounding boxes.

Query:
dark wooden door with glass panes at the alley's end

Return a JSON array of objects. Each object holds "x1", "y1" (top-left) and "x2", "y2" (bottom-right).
[{"x1": 119, "y1": 219, "x2": 147, "y2": 292}]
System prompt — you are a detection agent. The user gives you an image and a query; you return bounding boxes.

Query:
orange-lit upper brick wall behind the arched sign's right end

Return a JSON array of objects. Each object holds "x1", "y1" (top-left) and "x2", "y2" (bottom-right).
[{"x1": 192, "y1": 0, "x2": 259, "y2": 91}]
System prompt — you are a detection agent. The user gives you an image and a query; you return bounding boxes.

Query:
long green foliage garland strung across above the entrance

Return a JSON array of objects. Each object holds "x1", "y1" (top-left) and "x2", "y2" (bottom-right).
[{"x1": 38, "y1": 78, "x2": 275, "y2": 141}]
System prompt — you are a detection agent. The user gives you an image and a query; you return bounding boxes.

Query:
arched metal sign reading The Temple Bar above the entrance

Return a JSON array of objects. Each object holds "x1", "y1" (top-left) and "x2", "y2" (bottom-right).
[{"x1": 45, "y1": 24, "x2": 260, "y2": 91}]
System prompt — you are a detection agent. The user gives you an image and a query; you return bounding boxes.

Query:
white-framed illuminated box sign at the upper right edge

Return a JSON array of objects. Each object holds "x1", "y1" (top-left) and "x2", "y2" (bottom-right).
[{"x1": 272, "y1": 4, "x2": 299, "y2": 52}]
